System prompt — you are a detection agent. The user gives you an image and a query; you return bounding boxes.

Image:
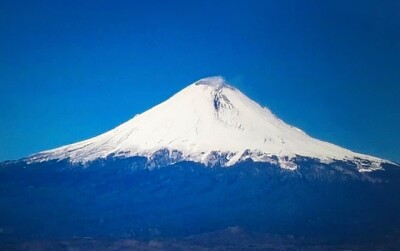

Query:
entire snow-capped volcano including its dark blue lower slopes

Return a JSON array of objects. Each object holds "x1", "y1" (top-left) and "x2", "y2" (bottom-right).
[{"x1": 0, "y1": 77, "x2": 400, "y2": 250}]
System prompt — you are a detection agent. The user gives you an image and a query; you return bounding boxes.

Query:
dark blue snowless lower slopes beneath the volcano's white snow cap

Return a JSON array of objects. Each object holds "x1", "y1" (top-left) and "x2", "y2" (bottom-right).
[{"x1": 0, "y1": 157, "x2": 400, "y2": 248}]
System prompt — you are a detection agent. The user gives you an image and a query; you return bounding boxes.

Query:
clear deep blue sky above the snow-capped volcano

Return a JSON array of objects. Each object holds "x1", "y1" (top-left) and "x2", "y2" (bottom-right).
[{"x1": 0, "y1": 0, "x2": 400, "y2": 162}]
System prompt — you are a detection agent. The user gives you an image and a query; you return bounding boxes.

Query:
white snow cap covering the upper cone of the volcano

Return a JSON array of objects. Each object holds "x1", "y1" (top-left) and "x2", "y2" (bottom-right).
[{"x1": 30, "y1": 77, "x2": 386, "y2": 171}]
